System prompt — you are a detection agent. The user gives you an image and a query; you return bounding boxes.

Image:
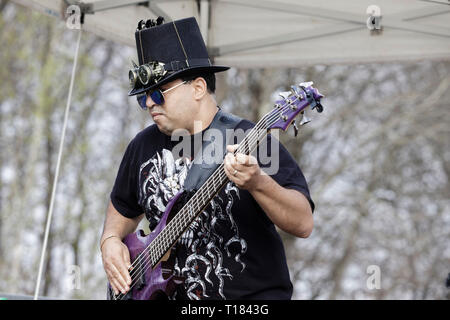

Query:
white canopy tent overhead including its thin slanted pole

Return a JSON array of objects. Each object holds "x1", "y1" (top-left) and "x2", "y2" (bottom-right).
[{"x1": 7, "y1": 0, "x2": 450, "y2": 299}]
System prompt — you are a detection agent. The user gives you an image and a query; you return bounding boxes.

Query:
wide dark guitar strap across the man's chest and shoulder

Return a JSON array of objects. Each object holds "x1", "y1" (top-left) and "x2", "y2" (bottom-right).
[{"x1": 183, "y1": 109, "x2": 242, "y2": 193}]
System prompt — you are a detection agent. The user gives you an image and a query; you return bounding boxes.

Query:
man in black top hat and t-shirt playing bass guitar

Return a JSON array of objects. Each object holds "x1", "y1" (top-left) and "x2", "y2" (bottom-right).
[{"x1": 100, "y1": 18, "x2": 314, "y2": 299}]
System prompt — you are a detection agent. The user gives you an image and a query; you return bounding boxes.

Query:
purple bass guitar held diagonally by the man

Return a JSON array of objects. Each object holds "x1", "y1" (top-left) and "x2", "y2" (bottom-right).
[{"x1": 108, "y1": 82, "x2": 323, "y2": 300}]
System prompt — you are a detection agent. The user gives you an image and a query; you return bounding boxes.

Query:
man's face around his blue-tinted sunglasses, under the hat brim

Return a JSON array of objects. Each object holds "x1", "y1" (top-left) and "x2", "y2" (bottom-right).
[{"x1": 146, "y1": 79, "x2": 196, "y2": 135}]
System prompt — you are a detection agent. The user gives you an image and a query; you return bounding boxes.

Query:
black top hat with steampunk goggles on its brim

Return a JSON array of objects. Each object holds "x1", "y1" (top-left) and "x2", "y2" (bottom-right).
[{"x1": 128, "y1": 17, "x2": 229, "y2": 96}]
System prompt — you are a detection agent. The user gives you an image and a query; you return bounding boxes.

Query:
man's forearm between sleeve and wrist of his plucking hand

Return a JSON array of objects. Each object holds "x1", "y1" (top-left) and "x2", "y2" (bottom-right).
[{"x1": 100, "y1": 202, "x2": 143, "y2": 243}]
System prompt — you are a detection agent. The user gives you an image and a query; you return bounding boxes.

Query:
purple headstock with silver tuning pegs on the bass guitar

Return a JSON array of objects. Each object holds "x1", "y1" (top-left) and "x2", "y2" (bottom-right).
[{"x1": 266, "y1": 82, "x2": 323, "y2": 135}]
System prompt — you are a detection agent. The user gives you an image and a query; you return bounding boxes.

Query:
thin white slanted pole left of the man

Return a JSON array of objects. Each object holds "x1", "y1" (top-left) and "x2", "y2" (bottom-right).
[{"x1": 34, "y1": 28, "x2": 82, "y2": 300}]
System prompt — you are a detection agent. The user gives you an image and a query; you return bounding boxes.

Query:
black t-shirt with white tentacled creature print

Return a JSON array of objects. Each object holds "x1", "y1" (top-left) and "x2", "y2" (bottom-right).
[{"x1": 111, "y1": 120, "x2": 314, "y2": 300}]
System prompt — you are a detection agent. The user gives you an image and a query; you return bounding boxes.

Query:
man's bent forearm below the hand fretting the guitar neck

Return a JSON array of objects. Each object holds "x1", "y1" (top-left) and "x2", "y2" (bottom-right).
[{"x1": 249, "y1": 174, "x2": 314, "y2": 238}]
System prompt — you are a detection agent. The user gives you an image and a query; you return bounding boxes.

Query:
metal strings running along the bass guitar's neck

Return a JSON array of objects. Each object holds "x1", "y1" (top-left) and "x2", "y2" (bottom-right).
[{"x1": 112, "y1": 90, "x2": 309, "y2": 296}]
